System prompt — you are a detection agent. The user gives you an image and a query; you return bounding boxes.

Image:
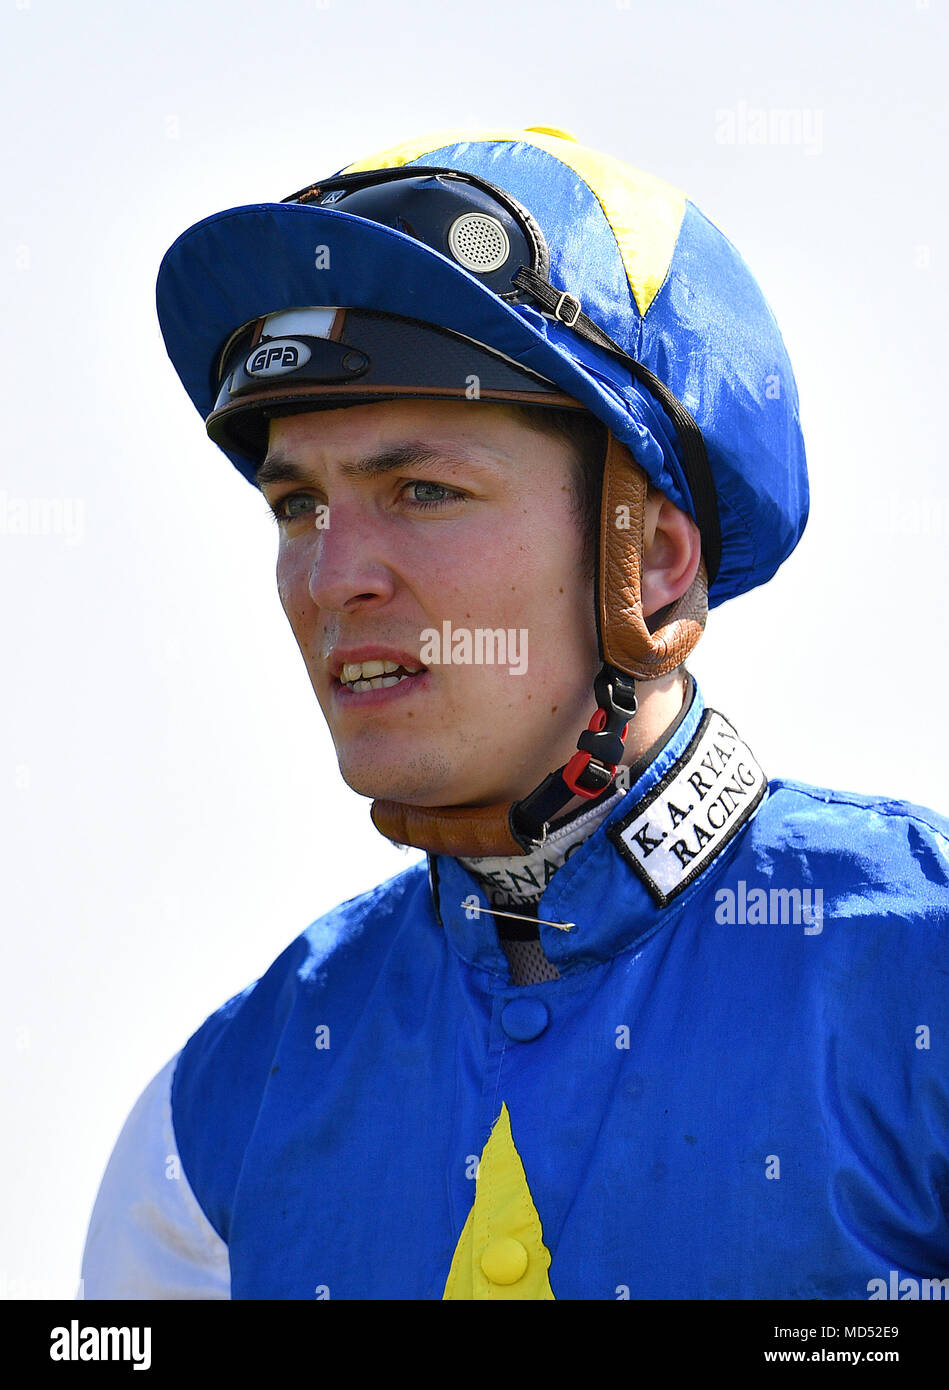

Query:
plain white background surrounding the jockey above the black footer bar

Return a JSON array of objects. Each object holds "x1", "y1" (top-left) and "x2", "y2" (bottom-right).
[{"x1": 0, "y1": 0, "x2": 949, "y2": 1298}]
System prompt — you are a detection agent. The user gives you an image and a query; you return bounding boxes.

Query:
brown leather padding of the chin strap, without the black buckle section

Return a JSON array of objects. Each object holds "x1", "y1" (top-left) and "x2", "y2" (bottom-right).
[{"x1": 371, "y1": 435, "x2": 709, "y2": 858}]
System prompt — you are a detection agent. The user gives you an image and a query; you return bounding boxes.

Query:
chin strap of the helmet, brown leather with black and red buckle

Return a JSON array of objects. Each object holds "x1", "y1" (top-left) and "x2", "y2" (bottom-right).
[{"x1": 371, "y1": 435, "x2": 709, "y2": 859}]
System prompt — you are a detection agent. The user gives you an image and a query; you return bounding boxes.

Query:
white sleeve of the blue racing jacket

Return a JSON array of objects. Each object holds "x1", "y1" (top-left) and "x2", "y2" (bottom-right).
[{"x1": 78, "y1": 1054, "x2": 231, "y2": 1300}]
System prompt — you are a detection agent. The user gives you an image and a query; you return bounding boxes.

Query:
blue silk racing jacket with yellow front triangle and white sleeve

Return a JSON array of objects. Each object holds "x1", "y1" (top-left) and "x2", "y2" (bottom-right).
[{"x1": 82, "y1": 688, "x2": 949, "y2": 1300}]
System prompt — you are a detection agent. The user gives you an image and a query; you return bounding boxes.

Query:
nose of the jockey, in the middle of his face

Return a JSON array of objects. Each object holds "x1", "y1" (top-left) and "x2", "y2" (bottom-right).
[{"x1": 300, "y1": 500, "x2": 396, "y2": 613}]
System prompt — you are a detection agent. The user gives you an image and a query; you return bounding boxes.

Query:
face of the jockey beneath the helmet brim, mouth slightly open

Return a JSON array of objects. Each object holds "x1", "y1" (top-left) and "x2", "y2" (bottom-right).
[{"x1": 258, "y1": 400, "x2": 599, "y2": 806}]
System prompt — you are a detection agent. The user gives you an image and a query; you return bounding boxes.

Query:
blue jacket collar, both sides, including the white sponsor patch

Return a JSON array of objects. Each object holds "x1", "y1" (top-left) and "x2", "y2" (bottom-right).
[{"x1": 428, "y1": 681, "x2": 767, "y2": 988}]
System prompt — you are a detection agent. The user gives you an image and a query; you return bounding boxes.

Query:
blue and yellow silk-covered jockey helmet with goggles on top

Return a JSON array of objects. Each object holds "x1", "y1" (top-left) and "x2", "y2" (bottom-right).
[{"x1": 158, "y1": 128, "x2": 807, "y2": 606}]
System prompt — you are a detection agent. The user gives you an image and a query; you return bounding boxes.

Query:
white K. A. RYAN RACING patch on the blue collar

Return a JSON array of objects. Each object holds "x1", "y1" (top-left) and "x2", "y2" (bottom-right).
[{"x1": 607, "y1": 709, "x2": 767, "y2": 906}]
